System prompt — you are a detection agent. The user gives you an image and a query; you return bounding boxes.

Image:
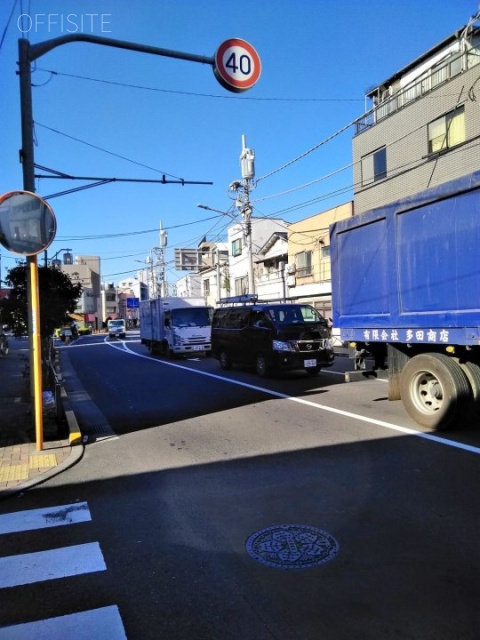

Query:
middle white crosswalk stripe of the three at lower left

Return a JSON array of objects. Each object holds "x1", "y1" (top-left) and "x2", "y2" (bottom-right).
[{"x1": 0, "y1": 542, "x2": 107, "y2": 588}]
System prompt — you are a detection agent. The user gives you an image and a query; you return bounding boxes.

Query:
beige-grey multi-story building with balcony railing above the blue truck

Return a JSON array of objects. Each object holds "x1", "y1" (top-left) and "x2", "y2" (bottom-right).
[{"x1": 353, "y1": 21, "x2": 480, "y2": 213}]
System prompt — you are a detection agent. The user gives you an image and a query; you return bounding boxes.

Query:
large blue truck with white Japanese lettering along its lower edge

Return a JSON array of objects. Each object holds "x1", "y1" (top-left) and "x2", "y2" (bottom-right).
[{"x1": 330, "y1": 171, "x2": 480, "y2": 431}]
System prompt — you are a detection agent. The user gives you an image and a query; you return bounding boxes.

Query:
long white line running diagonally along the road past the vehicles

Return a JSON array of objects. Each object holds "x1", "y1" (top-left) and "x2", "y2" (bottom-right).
[{"x1": 122, "y1": 344, "x2": 480, "y2": 455}]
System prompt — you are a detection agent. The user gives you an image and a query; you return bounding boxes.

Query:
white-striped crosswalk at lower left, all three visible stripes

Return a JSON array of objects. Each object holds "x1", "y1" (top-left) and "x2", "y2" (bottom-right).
[{"x1": 0, "y1": 502, "x2": 127, "y2": 640}]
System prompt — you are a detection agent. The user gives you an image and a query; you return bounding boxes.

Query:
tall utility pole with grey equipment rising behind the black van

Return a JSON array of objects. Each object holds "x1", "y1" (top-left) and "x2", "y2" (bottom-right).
[{"x1": 229, "y1": 135, "x2": 255, "y2": 294}]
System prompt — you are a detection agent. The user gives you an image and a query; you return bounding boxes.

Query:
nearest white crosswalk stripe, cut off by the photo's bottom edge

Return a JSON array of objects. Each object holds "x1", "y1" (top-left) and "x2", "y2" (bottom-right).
[{"x1": 0, "y1": 606, "x2": 127, "y2": 640}]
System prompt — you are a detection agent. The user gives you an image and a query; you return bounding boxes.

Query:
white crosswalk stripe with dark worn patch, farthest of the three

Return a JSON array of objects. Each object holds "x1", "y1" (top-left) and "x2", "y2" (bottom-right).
[{"x1": 0, "y1": 502, "x2": 92, "y2": 534}]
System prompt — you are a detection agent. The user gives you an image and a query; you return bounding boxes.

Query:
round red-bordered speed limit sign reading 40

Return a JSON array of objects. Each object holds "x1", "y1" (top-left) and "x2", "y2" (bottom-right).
[{"x1": 213, "y1": 38, "x2": 262, "y2": 93}]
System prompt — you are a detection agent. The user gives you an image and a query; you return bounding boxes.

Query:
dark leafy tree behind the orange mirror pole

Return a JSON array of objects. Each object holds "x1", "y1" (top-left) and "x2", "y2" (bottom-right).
[{"x1": 0, "y1": 263, "x2": 82, "y2": 338}]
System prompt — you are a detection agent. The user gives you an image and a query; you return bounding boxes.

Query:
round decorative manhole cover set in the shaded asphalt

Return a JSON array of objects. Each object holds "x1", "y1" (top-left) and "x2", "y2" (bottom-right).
[{"x1": 245, "y1": 524, "x2": 339, "y2": 569}]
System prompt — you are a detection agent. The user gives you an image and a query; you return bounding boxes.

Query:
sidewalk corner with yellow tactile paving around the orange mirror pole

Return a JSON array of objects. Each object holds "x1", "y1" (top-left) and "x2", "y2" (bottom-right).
[{"x1": 0, "y1": 337, "x2": 83, "y2": 500}]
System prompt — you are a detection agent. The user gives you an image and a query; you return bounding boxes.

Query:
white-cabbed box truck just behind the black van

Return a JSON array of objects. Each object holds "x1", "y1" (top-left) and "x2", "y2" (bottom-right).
[{"x1": 140, "y1": 297, "x2": 213, "y2": 358}]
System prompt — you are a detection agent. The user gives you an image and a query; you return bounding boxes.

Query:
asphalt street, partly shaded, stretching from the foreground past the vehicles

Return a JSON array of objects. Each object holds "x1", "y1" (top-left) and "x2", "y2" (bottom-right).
[{"x1": 0, "y1": 334, "x2": 480, "y2": 640}]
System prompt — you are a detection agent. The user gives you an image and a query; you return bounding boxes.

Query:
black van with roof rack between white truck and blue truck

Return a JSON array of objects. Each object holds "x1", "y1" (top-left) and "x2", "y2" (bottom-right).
[{"x1": 212, "y1": 302, "x2": 334, "y2": 377}]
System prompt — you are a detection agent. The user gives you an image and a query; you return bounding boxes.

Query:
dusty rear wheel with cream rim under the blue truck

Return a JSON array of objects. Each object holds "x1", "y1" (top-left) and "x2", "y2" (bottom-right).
[{"x1": 400, "y1": 353, "x2": 470, "y2": 431}]
